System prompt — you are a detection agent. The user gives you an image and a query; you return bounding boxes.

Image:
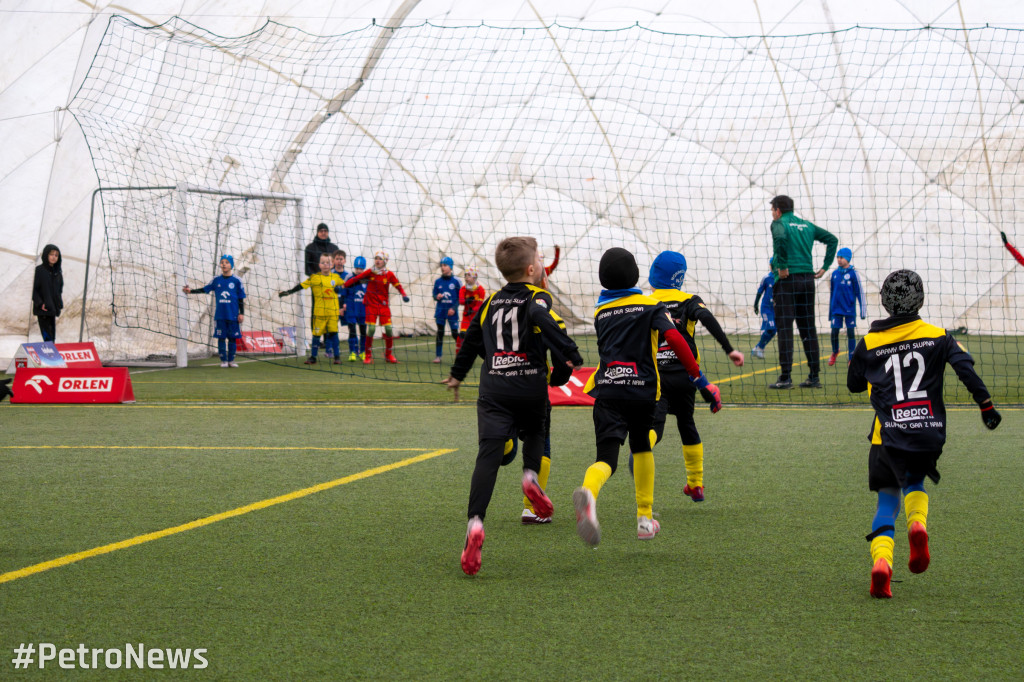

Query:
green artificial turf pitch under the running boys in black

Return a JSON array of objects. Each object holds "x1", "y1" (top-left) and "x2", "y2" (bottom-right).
[{"x1": 0, "y1": 363, "x2": 1024, "y2": 680}]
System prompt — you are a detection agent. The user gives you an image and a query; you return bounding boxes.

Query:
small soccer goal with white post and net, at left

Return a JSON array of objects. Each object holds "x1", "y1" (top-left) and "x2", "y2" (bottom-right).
[{"x1": 83, "y1": 184, "x2": 307, "y2": 367}]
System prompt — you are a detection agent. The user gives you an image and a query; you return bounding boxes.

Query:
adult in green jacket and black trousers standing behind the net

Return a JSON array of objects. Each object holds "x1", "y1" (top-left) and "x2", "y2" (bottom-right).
[{"x1": 768, "y1": 195, "x2": 839, "y2": 388}]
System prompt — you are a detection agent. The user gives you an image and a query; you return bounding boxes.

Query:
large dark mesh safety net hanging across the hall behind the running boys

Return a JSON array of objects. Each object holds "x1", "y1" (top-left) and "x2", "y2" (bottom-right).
[{"x1": 72, "y1": 17, "x2": 1024, "y2": 402}]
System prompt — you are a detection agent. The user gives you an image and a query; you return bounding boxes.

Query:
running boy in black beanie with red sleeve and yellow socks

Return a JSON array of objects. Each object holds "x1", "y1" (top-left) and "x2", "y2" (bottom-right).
[{"x1": 572, "y1": 248, "x2": 722, "y2": 545}]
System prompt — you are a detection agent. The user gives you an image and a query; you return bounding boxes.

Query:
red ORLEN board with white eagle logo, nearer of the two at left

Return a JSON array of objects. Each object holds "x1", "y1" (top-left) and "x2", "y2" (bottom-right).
[{"x1": 10, "y1": 367, "x2": 135, "y2": 403}]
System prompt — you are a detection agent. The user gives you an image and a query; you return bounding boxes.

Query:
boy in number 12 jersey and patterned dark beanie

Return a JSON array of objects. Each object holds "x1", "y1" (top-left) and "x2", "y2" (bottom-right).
[{"x1": 846, "y1": 270, "x2": 1001, "y2": 598}]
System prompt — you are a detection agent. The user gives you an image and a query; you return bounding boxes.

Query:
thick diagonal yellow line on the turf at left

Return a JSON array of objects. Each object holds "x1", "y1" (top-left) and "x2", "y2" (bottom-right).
[{"x1": 0, "y1": 449, "x2": 455, "y2": 584}]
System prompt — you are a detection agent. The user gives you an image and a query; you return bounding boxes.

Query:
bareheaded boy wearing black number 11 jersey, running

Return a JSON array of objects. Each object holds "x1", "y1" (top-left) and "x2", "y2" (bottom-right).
[{"x1": 445, "y1": 237, "x2": 583, "y2": 576}]
